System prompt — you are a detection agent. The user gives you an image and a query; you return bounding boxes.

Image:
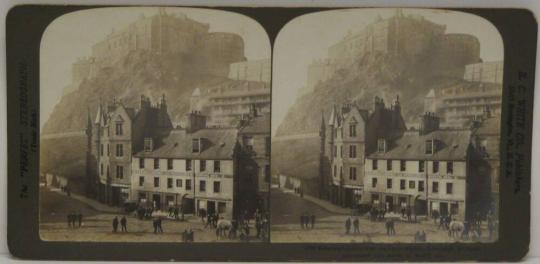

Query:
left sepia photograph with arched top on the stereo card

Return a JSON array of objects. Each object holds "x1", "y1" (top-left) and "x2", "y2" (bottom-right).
[{"x1": 39, "y1": 7, "x2": 271, "y2": 243}]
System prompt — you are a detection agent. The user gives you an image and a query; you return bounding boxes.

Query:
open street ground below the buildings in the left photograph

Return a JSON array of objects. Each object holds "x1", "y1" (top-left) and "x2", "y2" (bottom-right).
[{"x1": 40, "y1": 189, "x2": 260, "y2": 242}]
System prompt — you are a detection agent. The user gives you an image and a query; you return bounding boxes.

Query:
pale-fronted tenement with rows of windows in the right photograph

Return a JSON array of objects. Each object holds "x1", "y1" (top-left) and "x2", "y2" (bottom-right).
[{"x1": 364, "y1": 110, "x2": 490, "y2": 219}]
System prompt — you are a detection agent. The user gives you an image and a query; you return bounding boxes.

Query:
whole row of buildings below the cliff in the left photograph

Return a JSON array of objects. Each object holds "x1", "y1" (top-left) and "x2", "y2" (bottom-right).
[{"x1": 87, "y1": 96, "x2": 270, "y2": 218}]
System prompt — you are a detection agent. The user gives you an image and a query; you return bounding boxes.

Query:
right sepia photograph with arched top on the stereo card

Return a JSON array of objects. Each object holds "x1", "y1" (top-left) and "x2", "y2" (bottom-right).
[{"x1": 270, "y1": 8, "x2": 504, "y2": 243}]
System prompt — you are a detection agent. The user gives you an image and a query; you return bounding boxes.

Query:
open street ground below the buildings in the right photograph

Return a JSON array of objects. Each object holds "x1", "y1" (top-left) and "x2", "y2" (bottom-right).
[{"x1": 271, "y1": 189, "x2": 496, "y2": 243}]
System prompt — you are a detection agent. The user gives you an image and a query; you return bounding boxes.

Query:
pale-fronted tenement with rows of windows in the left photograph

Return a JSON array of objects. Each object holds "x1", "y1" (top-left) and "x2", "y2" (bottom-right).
[{"x1": 131, "y1": 106, "x2": 264, "y2": 219}]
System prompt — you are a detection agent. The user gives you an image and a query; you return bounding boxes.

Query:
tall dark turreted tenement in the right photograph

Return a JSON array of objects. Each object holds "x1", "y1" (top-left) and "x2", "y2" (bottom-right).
[{"x1": 319, "y1": 97, "x2": 406, "y2": 207}]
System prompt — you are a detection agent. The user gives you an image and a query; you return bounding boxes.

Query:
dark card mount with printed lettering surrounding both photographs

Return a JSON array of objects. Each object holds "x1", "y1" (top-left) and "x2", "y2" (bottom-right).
[{"x1": 6, "y1": 5, "x2": 537, "y2": 261}]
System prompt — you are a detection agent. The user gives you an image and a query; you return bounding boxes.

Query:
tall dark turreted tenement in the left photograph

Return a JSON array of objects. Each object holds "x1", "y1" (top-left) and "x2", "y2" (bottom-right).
[{"x1": 87, "y1": 96, "x2": 172, "y2": 205}]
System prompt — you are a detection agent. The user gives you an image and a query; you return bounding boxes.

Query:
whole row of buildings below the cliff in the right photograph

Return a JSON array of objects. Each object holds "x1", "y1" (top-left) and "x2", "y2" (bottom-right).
[{"x1": 312, "y1": 95, "x2": 500, "y2": 219}]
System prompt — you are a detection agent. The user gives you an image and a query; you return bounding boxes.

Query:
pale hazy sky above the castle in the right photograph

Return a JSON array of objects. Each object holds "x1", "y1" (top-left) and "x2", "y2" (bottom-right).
[{"x1": 272, "y1": 8, "x2": 504, "y2": 135}]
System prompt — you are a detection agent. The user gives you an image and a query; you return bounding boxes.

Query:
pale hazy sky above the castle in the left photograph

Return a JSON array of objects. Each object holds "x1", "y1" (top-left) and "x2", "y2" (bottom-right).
[{"x1": 40, "y1": 7, "x2": 271, "y2": 127}]
